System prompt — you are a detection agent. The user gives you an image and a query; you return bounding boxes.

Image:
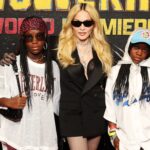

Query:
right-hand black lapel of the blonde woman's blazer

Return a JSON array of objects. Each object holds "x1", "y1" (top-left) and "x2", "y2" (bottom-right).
[{"x1": 82, "y1": 51, "x2": 103, "y2": 94}]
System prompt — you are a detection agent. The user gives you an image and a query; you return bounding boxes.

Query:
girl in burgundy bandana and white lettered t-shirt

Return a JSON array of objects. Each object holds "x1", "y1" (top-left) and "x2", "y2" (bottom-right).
[{"x1": 0, "y1": 16, "x2": 60, "y2": 150}]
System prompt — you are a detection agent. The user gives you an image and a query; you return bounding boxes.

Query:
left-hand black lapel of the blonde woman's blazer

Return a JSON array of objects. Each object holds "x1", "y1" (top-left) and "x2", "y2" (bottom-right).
[{"x1": 67, "y1": 50, "x2": 86, "y2": 89}]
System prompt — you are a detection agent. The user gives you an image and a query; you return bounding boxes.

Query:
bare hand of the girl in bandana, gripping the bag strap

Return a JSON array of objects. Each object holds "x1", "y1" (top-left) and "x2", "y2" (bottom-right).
[{"x1": 5, "y1": 96, "x2": 27, "y2": 109}]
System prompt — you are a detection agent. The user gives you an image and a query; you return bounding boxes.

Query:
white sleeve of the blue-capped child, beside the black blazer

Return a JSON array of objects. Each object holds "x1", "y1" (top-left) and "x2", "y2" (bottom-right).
[{"x1": 104, "y1": 66, "x2": 119, "y2": 123}]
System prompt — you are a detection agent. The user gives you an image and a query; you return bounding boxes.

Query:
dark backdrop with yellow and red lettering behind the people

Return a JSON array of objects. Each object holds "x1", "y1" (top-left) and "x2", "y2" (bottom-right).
[{"x1": 0, "y1": 0, "x2": 150, "y2": 61}]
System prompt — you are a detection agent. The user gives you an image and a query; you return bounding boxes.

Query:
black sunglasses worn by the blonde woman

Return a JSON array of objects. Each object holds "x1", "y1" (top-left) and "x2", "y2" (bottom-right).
[{"x1": 71, "y1": 20, "x2": 94, "y2": 27}]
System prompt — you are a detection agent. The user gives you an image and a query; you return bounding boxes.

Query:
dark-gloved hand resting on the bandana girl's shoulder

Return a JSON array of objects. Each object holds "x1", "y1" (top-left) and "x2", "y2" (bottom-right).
[{"x1": 0, "y1": 52, "x2": 16, "y2": 66}]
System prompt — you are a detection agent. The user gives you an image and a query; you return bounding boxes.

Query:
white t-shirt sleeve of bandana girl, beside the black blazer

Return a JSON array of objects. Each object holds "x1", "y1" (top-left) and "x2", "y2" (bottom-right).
[{"x1": 53, "y1": 61, "x2": 61, "y2": 115}]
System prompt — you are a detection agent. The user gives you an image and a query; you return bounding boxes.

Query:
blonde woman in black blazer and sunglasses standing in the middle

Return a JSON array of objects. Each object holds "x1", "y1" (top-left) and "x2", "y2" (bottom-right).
[{"x1": 57, "y1": 4, "x2": 112, "y2": 150}]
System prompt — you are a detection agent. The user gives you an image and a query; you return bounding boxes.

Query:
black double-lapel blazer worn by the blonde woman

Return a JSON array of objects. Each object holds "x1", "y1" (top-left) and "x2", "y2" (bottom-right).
[{"x1": 60, "y1": 50, "x2": 106, "y2": 136}]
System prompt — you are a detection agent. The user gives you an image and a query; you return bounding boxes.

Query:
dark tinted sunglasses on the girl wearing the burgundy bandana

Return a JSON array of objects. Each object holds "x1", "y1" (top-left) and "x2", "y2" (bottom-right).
[{"x1": 24, "y1": 32, "x2": 46, "y2": 42}]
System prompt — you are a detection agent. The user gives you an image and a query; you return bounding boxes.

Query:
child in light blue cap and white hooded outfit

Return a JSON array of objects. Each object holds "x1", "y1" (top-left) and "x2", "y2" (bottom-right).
[{"x1": 104, "y1": 29, "x2": 150, "y2": 150}]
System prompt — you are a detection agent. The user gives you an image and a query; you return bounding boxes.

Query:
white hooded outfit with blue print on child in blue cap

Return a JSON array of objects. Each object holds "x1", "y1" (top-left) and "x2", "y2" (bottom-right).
[{"x1": 104, "y1": 28, "x2": 150, "y2": 150}]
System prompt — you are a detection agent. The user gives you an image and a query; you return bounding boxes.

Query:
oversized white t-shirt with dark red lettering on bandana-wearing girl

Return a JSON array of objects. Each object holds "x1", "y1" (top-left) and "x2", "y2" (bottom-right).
[{"x1": 0, "y1": 56, "x2": 60, "y2": 150}]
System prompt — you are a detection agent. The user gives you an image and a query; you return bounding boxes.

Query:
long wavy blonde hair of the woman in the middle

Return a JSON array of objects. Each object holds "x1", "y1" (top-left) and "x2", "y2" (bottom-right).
[{"x1": 57, "y1": 4, "x2": 112, "y2": 74}]
